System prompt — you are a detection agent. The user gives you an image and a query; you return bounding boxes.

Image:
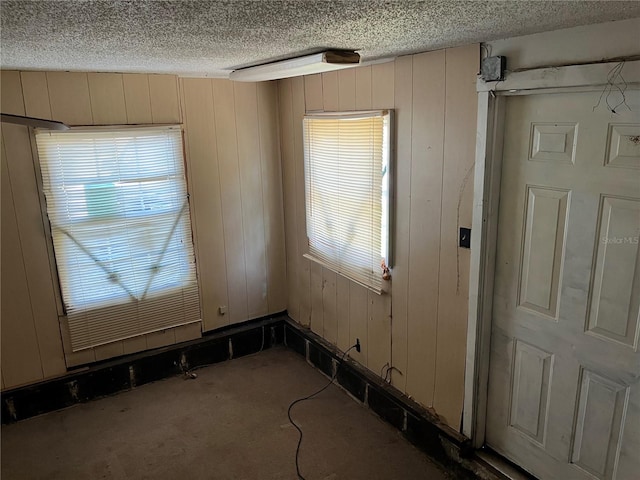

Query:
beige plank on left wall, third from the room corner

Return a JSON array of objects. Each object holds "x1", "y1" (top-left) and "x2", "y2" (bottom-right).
[{"x1": 213, "y1": 80, "x2": 247, "y2": 323}]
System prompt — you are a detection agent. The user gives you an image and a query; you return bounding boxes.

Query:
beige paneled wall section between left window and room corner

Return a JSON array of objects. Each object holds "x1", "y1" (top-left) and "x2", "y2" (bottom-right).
[{"x1": 180, "y1": 78, "x2": 287, "y2": 330}]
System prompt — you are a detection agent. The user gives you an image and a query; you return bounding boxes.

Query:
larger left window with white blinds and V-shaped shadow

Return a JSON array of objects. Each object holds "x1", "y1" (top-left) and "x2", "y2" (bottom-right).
[{"x1": 36, "y1": 126, "x2": 200, "y2": 351}]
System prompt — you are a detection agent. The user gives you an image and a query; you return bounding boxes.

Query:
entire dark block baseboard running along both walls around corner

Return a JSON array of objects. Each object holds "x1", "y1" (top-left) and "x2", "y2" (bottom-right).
[{"x1": 1, "y1": 312, "x2": 507, "y2": 480}]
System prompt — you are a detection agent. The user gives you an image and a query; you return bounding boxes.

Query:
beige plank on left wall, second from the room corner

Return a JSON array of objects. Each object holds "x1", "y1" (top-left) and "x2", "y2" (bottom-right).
[{"x1": 233, "y1": 82, "x2": 269, "y2": 318}]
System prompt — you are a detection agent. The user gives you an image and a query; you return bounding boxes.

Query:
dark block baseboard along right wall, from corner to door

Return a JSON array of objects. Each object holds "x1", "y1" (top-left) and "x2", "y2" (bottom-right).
[{"x1": 284, "y1": 317, "x2": 506, "y2": 479}]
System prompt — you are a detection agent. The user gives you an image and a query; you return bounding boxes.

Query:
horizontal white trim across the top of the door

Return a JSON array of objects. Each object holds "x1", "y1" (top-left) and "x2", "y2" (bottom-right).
[{"x1": 476, "y1": 60, "x2": 640, "y2": 95}]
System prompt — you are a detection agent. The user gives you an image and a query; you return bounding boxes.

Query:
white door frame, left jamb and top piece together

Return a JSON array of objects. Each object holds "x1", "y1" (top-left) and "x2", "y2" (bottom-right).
[{"x1": 462, "y1": 57, "x2": 640, "y2": 448}]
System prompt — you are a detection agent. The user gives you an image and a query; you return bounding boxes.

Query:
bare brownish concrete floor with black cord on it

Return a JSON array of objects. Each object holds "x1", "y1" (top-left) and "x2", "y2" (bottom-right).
[{"x1": 1, "y1": 348, "x2": 450, "y2": 480}]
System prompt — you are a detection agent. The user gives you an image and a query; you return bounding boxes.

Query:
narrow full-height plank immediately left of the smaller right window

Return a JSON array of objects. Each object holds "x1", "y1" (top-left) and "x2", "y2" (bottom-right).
[{"x1": 291, "y1": 77, "x2": 312, "y2": 324}]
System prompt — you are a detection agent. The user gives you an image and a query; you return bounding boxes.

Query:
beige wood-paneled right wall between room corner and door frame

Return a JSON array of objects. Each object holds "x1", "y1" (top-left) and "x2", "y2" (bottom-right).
[{"x1": 278, "y1": 45, "x2": 480, "y2": 429}]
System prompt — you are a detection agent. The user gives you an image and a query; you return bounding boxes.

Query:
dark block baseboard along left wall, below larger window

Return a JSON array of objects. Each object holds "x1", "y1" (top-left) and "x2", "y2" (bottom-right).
[{"x1": 1, "y1": 313, "x2": 287, "y2": 424}]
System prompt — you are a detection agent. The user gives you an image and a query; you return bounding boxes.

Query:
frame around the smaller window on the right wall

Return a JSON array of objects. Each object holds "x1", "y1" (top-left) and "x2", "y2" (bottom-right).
[{"x1": 302, "y1": 109, "x2": 395, "y2": 295}]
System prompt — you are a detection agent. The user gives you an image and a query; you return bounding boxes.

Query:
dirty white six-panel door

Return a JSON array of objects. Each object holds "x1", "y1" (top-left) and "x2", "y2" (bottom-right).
[{"x1": 486, "y1": 91, "x2": 640, "y2": 480}]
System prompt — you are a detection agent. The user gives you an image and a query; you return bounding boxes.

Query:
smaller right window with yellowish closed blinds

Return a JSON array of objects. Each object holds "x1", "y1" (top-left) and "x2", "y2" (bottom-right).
[{"x1": 304, "y1": 110, "x2": 391, "y2": 292}]
